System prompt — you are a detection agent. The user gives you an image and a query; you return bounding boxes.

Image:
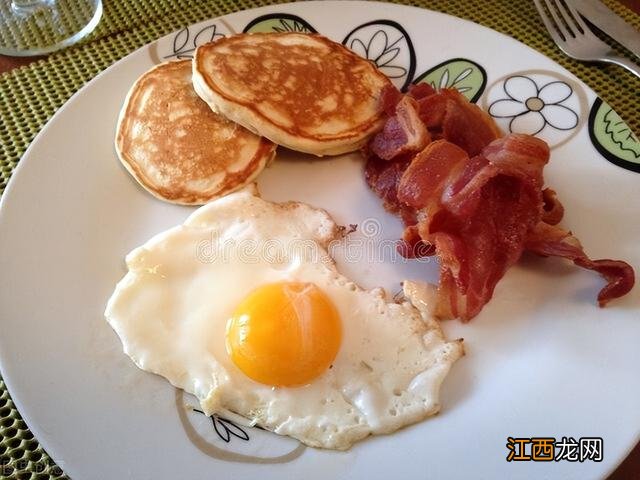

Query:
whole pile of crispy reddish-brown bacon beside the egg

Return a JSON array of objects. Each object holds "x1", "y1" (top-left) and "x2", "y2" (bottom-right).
[{"x1": 366, "y1": 84, "x2": 635, "y2": 321}]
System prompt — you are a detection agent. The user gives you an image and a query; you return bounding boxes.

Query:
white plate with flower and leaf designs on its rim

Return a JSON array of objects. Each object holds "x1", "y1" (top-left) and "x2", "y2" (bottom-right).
[{"x1": 0, "y1": 2, "x2": 640, "y2": 480}]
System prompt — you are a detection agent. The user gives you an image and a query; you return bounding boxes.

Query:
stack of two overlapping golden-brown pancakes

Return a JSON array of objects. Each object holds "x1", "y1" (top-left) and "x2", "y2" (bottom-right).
[{"x1": 116, "y1": 33, "x2": 389, "y2": 205}]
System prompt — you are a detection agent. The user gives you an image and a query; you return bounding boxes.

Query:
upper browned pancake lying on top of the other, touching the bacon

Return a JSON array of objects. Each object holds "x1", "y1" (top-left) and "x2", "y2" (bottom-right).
[{"x1": 193, "y1": 32, "x2": 390, "y2": 156}]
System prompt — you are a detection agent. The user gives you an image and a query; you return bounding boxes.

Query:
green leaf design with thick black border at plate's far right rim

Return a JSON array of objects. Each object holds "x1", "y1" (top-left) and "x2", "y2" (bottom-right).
[{"x1": 589, "y1": 98, "x2": 640, "y2": 172}]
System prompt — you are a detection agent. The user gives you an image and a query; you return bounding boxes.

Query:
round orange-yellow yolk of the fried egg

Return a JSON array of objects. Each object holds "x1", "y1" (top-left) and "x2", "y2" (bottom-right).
[{"x1": 226, "y1": 282, "x2": 342, "y2": 387}]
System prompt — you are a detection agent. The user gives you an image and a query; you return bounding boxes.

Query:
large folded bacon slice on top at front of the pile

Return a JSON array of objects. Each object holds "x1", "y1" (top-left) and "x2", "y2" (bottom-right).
[{"x1": 397, "y1": 135, "x2": 549, "y2": 321}]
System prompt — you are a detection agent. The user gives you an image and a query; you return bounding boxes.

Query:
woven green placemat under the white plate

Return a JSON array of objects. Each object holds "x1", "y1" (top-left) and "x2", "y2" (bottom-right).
[{"x1": 0, "y1": 0, "x2": 640, "y2": 480}]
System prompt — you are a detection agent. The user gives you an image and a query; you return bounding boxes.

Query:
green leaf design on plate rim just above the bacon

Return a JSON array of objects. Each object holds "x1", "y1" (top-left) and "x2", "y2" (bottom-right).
[{"x1": 413, "y1": 58, "x2": 487, "y2": 102}]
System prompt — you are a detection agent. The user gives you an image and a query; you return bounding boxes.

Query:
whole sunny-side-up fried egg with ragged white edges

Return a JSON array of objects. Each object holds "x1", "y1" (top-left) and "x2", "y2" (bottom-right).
[{"x1": 105, "y1": 186, "x2": 463, "y2": 449}]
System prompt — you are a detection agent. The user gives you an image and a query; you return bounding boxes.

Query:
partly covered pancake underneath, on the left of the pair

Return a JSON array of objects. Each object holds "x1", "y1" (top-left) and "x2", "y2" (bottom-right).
[{"x1": 116, "y1": 60, "x2": 276, "y2": 205}]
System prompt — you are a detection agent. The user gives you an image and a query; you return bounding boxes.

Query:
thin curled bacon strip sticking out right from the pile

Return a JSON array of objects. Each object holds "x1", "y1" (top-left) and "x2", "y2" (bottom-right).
[{"x1": 525, "y1": 222, "x2": 635, "y2": 307}]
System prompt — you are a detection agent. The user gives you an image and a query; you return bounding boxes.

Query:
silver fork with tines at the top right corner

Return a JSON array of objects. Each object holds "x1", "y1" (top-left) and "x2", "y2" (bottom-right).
[{"x1": 533, "y1": 0, "x2": 640, "y2": 78}]
